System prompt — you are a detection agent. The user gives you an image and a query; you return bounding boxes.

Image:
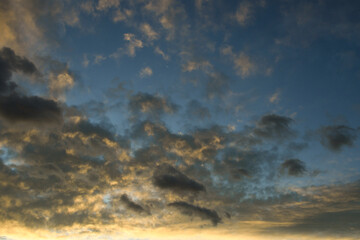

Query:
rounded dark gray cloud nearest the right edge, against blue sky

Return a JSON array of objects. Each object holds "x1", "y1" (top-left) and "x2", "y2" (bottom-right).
[{"x1": 320, "y1": 125, "x2": 357, "y2": 151}]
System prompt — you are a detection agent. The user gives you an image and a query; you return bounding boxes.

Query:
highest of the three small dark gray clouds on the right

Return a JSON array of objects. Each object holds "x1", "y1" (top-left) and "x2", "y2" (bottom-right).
[{"x1": 254, "y1": 114, "x2": 295, "y2": 140}]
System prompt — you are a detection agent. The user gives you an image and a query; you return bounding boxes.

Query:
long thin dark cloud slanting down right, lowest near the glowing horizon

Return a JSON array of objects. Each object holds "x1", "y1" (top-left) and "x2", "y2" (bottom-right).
[{"x1": 168, "y1": 201, "x2": 221, "y2": 226}]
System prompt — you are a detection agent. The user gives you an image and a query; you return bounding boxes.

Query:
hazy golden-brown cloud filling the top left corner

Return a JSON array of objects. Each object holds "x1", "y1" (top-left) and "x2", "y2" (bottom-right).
[{"x1": 0, "y1": 0, "x2": 80, "y2": 56}]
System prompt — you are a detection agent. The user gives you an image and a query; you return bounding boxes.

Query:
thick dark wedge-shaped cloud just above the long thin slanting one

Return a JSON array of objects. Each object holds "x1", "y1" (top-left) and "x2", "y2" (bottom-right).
[{"x1": 153, "y1": 165, "x2": 206, "y2": 193}]
